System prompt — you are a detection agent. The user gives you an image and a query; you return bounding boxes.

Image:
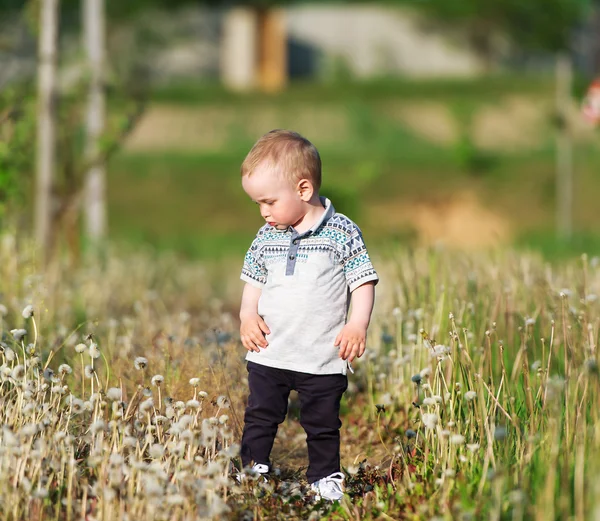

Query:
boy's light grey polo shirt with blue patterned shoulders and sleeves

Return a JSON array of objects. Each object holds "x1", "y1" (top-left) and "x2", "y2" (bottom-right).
[{"x1": 241, "y1": 197, "x2": 379, "y2": 374}]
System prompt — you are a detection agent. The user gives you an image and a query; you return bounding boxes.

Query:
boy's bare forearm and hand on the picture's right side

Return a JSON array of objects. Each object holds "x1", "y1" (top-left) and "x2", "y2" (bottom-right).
[{"x1": 334, "y1": 282, "x2": 375, "y2": 362}]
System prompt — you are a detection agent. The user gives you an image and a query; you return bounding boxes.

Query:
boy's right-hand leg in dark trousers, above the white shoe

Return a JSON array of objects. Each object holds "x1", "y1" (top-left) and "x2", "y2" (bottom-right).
[{"x1": 296, "y1": 374, "x2": 348, "y2": 483}]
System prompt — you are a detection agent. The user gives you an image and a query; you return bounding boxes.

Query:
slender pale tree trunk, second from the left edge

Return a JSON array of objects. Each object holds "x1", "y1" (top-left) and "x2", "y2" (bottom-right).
[{"x1": 82, "y1": 0, "x2": 106, "y2": 243}]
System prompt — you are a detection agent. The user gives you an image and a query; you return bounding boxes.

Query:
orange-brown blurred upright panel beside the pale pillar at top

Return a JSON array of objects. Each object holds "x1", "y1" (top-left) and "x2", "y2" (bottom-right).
[{"x1": 258, "y1": 8, "x2": 287, "y2": 92}]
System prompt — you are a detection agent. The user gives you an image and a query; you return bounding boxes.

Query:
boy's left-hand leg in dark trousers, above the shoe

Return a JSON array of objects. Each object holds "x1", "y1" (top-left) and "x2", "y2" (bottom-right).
[{"x1": 241, "y1": 362, "x2": 292, "y2": 467}]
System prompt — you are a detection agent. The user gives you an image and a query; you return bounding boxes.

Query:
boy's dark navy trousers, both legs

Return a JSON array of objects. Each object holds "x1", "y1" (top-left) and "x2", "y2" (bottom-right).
[{"x1": 241, "y1": 362, "x2": 348, "y2": 483}]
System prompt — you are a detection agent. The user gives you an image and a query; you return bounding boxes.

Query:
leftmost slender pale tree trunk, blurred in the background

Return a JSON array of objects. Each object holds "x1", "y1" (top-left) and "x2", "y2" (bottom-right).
[{"x1": 35, "y1": 0, "x2": 59, "y2": 262}]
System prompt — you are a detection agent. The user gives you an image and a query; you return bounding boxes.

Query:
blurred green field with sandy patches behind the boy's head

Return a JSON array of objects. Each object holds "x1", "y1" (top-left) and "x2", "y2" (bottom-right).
[{"x1": 108, "y1": 75, "x2": 600, "y2": 259}]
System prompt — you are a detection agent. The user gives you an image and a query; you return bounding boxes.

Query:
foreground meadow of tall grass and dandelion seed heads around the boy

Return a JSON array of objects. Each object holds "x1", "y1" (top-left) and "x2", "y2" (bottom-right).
[{"x1": 0, "y1": 233, "x2": 600, "y2": 521}]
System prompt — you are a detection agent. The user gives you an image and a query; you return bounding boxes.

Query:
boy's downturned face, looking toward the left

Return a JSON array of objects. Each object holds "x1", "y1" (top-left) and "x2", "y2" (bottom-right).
[{"x1": 242, "y1": 161, "x2": 312, "y2": 230}]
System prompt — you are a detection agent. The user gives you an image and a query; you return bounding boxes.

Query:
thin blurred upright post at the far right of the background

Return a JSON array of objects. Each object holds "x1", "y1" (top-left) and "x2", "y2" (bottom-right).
[{"x1": 556, "y1": 53, "x2": 573, "y2": 240}]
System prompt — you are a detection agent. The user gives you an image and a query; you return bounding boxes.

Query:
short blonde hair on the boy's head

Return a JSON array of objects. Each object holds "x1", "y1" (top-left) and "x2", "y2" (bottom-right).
[{"x1": 242, "y1": 129, "x2": 321, "y2": 191}]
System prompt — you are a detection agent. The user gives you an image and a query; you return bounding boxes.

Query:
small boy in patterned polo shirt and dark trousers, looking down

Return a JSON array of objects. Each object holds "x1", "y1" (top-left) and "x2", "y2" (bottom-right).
[{"x1": 240, "y1": 130, "x2": 378, "y2": 501}]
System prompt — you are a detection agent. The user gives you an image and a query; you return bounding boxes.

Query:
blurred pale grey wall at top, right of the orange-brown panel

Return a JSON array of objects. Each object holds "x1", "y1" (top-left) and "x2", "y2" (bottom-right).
[{"x1": 287, "y1": 5, "x2": 483, "y2": 77}]
